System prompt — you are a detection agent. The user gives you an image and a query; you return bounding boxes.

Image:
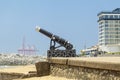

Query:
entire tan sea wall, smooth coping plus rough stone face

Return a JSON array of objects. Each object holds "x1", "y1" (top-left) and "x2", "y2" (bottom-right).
[{"x1": 48, "y1": 58, "x2": 120, "y2": 80}]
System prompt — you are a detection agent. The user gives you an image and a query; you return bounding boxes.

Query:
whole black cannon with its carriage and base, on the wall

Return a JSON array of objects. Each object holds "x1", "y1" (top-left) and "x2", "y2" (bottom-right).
[{"x1": 36, "y1": 26, "x2": 76, "y2": 57}]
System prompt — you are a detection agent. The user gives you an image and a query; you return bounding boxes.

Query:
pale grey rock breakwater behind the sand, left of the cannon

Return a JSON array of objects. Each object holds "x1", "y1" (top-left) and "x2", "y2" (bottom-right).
[{"x1": 0, "y1": 54, "x2": 45, "y2": 66}]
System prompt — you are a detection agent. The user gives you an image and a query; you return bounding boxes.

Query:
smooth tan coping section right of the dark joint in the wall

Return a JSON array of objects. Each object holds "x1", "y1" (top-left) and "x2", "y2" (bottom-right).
[{"x1": 68, "y1": 59, "x2": 120, "y2": 71}]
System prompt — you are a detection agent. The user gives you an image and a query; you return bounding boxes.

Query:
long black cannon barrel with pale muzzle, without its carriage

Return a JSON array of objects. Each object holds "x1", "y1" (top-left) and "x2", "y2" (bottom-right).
[{"x1": 36, "y1": 27, "x2": 73, "y2": 50}]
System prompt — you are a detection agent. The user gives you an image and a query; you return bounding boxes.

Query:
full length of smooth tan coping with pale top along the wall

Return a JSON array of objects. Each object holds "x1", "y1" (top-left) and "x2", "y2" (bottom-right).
[{"x1": 48, "y1": 57, "x2": 120, "y2": 71}]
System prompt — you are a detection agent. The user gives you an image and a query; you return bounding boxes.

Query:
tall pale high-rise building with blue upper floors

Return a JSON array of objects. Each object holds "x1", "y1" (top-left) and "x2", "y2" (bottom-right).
[{"x1": 98, "y1": 8, "x2": 120, "y2": 52}]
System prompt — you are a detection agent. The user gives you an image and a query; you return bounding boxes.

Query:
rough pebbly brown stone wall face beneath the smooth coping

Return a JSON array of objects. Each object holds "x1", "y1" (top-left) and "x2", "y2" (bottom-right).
[{"x1": 50, "y1": 64, "x2": 120, "y2": 80}]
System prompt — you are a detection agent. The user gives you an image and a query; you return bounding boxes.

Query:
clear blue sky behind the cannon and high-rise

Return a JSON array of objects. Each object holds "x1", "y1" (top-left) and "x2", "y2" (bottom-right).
[{"x1": 0, "y1": 0, "x2": 120, "y2": 55}]
